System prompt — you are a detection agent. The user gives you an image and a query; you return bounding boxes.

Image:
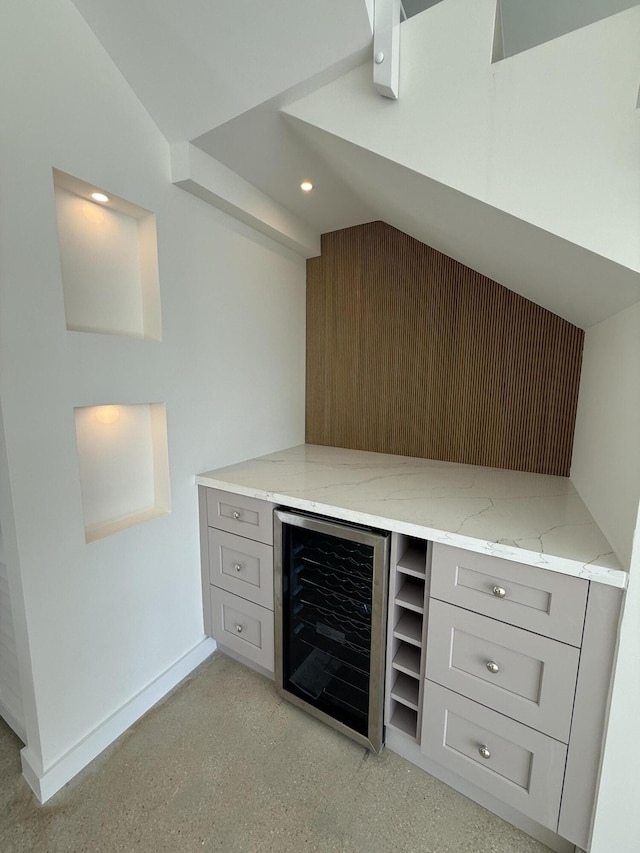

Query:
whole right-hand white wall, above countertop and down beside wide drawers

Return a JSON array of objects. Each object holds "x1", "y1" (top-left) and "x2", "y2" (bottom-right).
[{"x1": 571, "y1": 303, "x2": 640, "y2": 853}]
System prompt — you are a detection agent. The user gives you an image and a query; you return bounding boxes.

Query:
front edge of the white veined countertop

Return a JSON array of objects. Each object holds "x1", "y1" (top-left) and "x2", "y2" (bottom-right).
[{"x1": 195, "y1": 474, "x2": 628, "y2": 589}]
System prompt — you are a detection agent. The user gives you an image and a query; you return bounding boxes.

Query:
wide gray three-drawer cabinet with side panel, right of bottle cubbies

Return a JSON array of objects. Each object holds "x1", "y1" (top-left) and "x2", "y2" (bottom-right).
[{"x1": 420, "y1": 544, "x2": 620, "y2": 849}]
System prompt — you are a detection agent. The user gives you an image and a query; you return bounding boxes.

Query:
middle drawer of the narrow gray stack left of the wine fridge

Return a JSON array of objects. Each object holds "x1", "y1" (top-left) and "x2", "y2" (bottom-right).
[{"x1": 208, "y1": 527, "x2": 273, "y2": 610}]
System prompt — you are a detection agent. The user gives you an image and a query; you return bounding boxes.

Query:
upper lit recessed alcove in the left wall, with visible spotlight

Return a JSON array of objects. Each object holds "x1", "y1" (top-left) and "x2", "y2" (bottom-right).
[{"x1": 53, "y1": 169, "x2": 162, "y2": 340}]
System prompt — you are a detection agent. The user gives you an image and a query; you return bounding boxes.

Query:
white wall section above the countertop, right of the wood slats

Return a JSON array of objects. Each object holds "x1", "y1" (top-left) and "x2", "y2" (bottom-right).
[{"x1": 571, "y1": 302, "x2": 640, "y2": 566}]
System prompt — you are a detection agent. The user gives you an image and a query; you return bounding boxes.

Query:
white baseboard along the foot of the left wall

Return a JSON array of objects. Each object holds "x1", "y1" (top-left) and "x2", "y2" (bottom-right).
[{"x1": 20, "y1": 637, "x2": 216, "y2": 803}]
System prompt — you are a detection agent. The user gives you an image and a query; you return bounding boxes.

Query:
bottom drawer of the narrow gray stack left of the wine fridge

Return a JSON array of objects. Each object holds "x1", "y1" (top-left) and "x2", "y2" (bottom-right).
[{"x1": 211, "y1": 587, "x2": 273, "y2": 672}]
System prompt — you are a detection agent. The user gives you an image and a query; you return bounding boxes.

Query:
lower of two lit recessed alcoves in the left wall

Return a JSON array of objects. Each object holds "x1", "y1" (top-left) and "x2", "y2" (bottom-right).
[{"x1": 74, "y1": 403, "x2": 170, "y2": 542}]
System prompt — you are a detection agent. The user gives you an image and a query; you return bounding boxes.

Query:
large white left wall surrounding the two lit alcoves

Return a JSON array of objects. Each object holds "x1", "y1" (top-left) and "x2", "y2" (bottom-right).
[{"x1": 0, "y1": 0, "x2": 305, "y2": 784}]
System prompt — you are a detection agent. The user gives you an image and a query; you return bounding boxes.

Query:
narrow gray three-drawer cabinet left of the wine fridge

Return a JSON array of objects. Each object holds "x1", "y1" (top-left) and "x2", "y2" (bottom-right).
[{"x1": 200, "y1": 486, "x2": 274, "y2": 674}]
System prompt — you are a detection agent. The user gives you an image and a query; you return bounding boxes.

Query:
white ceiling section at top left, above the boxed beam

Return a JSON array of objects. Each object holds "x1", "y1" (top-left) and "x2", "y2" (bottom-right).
[{"x1": 73, "y1": 0, "x2": 371, "y2": 142}]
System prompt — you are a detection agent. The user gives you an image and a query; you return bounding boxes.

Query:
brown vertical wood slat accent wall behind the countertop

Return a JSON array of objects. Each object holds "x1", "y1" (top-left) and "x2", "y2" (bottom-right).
[{"x1": 306, "y1": 222, "x2": 584, "y2": 476}]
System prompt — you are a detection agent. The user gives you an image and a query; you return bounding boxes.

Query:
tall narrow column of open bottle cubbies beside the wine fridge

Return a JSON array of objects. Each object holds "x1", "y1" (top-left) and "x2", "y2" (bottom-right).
[{"x1": 385, "y1": 534, "x2": 428, "y2": 740}]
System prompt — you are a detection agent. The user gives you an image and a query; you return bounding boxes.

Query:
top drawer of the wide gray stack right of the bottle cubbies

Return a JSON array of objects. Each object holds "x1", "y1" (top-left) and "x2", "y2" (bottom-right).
[{"x1": 431, "y1": 543, "x2": 589, "y2": 646}]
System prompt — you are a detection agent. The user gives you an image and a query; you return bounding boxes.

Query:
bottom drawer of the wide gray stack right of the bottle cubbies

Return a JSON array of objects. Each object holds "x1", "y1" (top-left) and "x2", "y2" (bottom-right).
[{"x1": 421, "y1": 681, "x2": 567, "y2": 831}]
